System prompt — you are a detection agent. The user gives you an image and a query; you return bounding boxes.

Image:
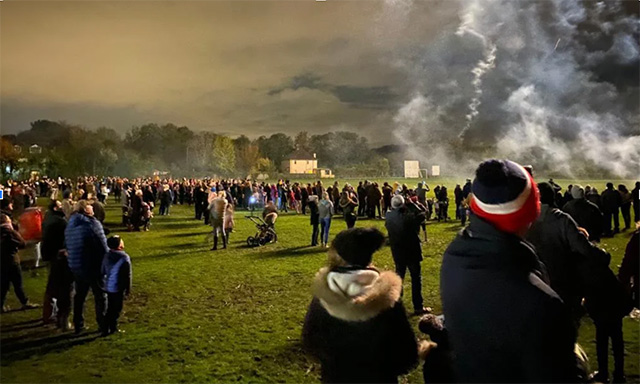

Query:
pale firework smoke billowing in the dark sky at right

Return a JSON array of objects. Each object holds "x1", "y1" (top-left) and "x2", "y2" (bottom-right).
[{"x1": 387, "y1": 0, "x2": 640, "y2": 178}]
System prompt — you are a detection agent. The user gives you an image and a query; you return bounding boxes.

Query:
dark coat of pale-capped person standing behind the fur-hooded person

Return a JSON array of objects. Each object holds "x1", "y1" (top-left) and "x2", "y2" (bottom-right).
[{"x1": 384, "y1": 207, "x2": 422, "y2": 263}]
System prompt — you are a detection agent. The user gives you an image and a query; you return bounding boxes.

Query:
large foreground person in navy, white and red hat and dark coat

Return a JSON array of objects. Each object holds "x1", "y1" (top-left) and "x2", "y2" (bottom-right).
[{"x1": 440, "y1": 160, "x2": 577, "y2": 383}]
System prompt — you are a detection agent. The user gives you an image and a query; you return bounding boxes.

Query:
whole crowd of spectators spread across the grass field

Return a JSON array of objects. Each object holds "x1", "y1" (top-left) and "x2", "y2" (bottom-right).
[{"x1": 0, "y1": 170, "x2": 640, "y2": 382}]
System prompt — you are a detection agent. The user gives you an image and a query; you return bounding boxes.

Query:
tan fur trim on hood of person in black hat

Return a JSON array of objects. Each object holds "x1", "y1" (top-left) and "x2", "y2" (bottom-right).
[{"x1": 312, "y1": 267, "x2": 402, "y2": 321}]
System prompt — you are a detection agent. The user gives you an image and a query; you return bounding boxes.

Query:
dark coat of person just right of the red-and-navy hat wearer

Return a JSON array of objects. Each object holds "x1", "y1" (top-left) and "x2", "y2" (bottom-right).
[{"x1": 526, "y1": 204, "x2": 610, "y2": 310}]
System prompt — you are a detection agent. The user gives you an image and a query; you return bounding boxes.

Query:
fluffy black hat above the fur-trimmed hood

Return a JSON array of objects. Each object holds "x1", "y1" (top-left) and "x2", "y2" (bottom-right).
[{"x1": 331, "y1": 228, "x2": 384, "y2": 268}]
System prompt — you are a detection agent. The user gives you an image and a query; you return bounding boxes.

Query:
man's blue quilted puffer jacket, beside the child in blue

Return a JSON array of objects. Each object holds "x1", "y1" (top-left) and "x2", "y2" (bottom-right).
[{"x1": 64, "y1": 213, "x2": 109, "y2": 279}]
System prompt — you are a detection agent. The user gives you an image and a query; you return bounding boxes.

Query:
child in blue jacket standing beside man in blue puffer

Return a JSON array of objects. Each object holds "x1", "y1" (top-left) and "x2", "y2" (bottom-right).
[{"x1": 102, "y1": 236, "x2": 132, "y2": 336}]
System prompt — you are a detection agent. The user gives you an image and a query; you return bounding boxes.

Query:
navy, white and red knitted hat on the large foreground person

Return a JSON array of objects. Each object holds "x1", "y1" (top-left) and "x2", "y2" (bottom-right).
[{"x1": 470, "y1": 159, "x2": 540, "y2": 233}]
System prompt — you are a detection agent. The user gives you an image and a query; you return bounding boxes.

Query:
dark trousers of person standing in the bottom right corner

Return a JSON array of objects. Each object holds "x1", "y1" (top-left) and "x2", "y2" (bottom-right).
[{"x1": 595, "y1": 319, "x2": 624, "y2": 374}]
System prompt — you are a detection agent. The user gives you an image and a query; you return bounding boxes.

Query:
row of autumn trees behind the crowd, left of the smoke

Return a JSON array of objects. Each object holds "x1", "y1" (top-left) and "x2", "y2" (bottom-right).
[{"x1": 0, "y1": 120, "x2": 392, "y2": 179}]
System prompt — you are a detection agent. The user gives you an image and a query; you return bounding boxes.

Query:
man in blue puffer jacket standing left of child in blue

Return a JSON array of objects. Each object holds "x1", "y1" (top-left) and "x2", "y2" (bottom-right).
[{"x1": 64, "y1": 200, "x2": 109, "y2": 333}]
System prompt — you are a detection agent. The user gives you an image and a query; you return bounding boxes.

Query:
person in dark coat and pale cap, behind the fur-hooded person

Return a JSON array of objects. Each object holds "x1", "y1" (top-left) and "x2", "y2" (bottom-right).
[{"x1": 385, "y1": 195, "x2": 430, "y2": 315}]
